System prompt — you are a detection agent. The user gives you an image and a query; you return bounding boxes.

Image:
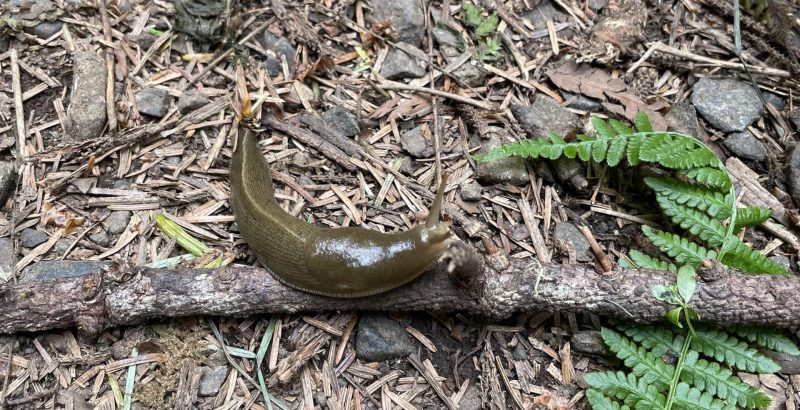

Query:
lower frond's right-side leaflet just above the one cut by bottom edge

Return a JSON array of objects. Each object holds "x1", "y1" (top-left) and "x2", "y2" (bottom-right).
[{"x1": 681, "y1": 350, "x2": 770, "y2": 409}]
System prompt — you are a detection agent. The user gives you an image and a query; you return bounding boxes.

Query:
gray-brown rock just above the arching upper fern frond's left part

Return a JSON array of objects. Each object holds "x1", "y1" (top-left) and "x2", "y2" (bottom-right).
[{"x1": 511, "y1": 95, "x2": 581, "y2": 138}]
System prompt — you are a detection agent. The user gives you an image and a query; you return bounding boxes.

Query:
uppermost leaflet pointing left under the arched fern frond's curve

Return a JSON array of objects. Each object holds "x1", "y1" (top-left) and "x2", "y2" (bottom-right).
[{"x1": 644, "y1": 177, "x2": 738, "y2": 221}]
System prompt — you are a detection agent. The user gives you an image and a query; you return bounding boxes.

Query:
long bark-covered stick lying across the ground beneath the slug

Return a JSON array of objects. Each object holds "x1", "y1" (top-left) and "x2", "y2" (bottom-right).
[{"x1": 0, "y1": 239, "x2": 800, "y2": 334}]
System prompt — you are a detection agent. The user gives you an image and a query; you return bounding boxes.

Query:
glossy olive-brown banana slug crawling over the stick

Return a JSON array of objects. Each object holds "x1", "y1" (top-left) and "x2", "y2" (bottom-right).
[{"x1": 230, "y1": 126, "x2": 450, "y2": 298}]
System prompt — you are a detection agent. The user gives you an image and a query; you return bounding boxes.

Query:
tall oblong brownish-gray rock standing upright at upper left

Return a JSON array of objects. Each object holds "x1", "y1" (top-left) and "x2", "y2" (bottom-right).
[{"x1": 66, "y1": 51, "x2": 107, "y2": 141}]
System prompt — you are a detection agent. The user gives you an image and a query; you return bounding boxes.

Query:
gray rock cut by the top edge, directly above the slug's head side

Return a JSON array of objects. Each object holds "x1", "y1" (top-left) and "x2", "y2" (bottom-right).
[{"x1": 372, "y1": 0, "x2": 425, "y2": 46}]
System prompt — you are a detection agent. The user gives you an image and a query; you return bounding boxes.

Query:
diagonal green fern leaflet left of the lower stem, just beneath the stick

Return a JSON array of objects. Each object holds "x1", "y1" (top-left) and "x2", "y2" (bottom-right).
[{"x1": 600, "y1": 327, "x2": 675, "y2": 390}]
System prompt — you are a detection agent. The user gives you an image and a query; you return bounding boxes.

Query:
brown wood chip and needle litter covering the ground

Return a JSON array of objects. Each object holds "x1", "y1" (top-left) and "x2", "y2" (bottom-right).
[{"x1": 0, "y1": 0, "x2": 800, "y2": 409}]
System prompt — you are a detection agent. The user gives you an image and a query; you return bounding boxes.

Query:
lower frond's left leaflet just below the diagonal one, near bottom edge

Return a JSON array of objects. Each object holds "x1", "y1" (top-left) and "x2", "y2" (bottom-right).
[{"x1": 584, "y1": 372, "x2": 667, "y2": 410}]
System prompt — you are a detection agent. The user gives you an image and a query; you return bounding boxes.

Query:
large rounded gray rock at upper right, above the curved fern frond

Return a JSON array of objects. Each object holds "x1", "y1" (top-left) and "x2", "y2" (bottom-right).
[{"x1": 692, "y1": 78, "x2": 764, "y2": 132}]
